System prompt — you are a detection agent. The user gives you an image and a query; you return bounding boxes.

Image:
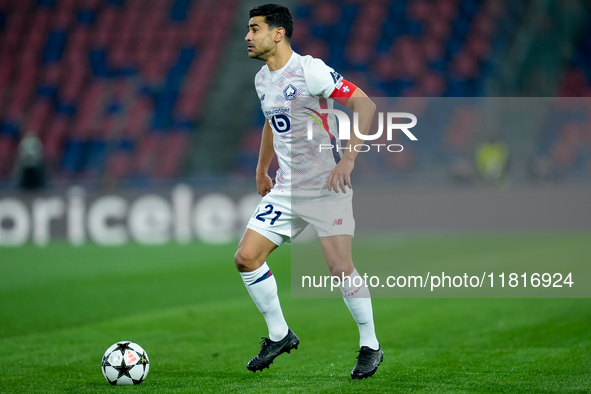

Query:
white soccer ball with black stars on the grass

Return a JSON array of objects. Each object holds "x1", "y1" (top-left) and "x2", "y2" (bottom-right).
[{"x1": 101, "y1": 341, "x2": 150, "y2": 385}]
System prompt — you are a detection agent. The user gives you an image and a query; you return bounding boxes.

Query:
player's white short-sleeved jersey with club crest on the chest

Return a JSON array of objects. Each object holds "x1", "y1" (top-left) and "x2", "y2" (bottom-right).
[{"x1": 255, "y1": 52, "x2": 343, "y2": 191}]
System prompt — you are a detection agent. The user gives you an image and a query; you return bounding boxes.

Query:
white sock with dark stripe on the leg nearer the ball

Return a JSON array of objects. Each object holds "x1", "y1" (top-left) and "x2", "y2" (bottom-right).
[{"x1": 240, "y1": 262, "x2": 289, "y2": 342}]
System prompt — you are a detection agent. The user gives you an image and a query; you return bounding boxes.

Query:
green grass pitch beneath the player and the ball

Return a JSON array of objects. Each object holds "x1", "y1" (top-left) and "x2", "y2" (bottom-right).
[{"x1": 0, "y1": 234, "x2": 591, "y2": 393}]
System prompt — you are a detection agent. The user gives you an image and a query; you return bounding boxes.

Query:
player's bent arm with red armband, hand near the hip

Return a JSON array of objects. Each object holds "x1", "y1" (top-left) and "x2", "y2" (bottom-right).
[{"x1": 327, "y1": 85, "x2": 376, "y2": 193}]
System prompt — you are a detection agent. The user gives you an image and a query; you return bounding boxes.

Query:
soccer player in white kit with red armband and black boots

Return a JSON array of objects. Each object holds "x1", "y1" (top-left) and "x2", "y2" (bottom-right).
[{"x1": 234, "y1": 4, "x2": 384, "y2": 379}]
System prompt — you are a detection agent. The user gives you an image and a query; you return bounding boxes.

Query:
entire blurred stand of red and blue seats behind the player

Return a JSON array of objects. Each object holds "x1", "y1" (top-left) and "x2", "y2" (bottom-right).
[{"x1": 0, "y1": 0, "x2": 591, "y2": 188}]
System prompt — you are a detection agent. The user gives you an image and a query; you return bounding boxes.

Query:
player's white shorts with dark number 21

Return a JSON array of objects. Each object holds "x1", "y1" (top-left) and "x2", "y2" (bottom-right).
[{"x1": 246, "y1": 189, "x2": 355, "y2": 245}]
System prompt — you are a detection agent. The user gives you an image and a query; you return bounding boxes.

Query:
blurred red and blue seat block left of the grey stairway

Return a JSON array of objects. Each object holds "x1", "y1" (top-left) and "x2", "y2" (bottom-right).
[{"x1": 0, "y1": 0, "x2": 236, "y2": 187}]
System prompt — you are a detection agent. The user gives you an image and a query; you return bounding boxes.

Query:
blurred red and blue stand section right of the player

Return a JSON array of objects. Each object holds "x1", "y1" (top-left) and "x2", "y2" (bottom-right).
[{"x1": 236, "y1": 0, "x2": 591, "y2": 181}]
